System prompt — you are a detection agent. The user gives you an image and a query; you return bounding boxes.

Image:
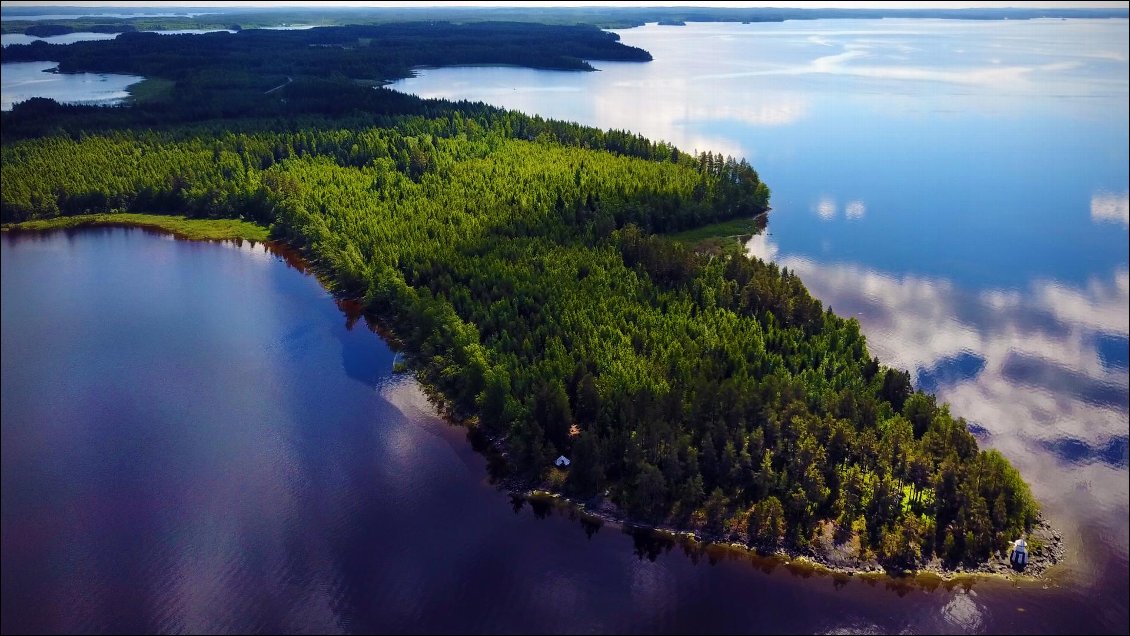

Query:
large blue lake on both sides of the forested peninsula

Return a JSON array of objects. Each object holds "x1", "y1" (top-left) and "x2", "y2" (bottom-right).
[{"x1": 0, "y1": 20, "x2": 1130, "y2": 633}]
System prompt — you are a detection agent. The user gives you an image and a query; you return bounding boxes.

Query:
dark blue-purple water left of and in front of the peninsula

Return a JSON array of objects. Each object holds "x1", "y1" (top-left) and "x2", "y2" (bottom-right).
[{"x1": 0, "y1": 228, "x2": 1127, "y2": 633}]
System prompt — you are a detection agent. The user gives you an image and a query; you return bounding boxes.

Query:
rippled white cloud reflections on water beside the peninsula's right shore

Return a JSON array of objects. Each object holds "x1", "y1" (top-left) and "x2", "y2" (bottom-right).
[{"x1": 747, "y1": 235, "x2": 1130, "y2": 555}]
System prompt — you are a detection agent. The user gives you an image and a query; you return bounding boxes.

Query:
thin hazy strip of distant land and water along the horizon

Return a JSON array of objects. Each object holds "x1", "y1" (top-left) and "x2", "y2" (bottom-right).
[{"x1": 0, "y1": 6, "x2": 1130, "y2": 33}]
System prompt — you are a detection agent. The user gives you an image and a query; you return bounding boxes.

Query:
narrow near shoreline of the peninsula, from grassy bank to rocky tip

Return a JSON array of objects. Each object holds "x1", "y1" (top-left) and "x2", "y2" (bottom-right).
[{"x1": 0, "y1": 218, "x2": 1066, "y2": 586}]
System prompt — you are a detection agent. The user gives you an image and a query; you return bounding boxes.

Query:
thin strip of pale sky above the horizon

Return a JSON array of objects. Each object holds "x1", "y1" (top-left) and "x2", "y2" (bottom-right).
[{"x1": 0, "y1": 0, "x2": 1130, "y2": 9}]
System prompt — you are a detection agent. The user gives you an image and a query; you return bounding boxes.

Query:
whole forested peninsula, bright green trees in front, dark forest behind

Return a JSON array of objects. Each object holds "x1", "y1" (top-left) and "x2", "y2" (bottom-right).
[{"x1": 0, "y1": 25, "x2": 1038, "y2": 568}]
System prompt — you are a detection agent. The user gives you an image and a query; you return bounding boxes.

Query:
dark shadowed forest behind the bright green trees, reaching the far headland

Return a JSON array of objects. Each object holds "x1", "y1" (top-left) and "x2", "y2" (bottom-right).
[{"x1": 0, "y1": 23, "x2": 651, "y2": 140}]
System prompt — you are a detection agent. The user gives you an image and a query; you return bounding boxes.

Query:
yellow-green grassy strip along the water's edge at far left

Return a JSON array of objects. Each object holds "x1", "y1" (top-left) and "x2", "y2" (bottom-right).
[{"x1": 3, "y1": 212, "x2": 268, "y2": 241}]
